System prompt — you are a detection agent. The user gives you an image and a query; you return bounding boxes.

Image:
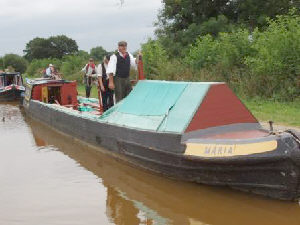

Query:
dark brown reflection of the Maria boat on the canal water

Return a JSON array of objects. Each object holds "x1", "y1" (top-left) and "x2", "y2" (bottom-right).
[{"x1": 26, "y1": 114, "x2": 300, "y2": 225}]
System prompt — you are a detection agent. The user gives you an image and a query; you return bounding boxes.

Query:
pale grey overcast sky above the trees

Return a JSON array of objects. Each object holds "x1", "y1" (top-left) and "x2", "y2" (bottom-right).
[{"x1": 0, "y1": 0, "x2": 162, "y2": 55}]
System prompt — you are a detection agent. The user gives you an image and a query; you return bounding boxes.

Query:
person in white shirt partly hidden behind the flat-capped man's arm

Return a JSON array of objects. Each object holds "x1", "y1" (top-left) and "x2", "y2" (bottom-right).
[{"x1": 97, "y1": 55, "x2": 114, "y2": 112}]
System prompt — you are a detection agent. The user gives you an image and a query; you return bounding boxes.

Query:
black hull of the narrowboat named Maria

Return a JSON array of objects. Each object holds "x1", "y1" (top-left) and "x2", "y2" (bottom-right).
[{"x1": 25, "y1": 101, "x2": 300, "y2": 200}]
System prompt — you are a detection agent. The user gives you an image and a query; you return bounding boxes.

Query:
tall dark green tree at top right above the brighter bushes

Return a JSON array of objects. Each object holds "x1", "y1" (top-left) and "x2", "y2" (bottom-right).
[{"x1": 156, "y1": 0, "x2": 299, "y2": 56}]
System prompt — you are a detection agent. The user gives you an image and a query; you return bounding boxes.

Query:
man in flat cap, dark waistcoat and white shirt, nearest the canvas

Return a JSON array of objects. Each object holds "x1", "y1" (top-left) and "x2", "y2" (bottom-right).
[{"x1": 106, "y1": 41, "x2": 140, "y2": 102}]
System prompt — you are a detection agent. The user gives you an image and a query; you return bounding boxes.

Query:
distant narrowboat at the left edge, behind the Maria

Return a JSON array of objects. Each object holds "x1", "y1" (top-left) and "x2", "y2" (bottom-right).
[{"x1": 0, "y1": 73, "x2": 25, "y2": 102}]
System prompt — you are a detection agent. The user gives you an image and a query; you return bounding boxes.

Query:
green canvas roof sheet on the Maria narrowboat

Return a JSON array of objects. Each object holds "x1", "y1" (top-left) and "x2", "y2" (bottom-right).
[{"x1": 100, "y1": 80, "x2": 219, "y2": 133}]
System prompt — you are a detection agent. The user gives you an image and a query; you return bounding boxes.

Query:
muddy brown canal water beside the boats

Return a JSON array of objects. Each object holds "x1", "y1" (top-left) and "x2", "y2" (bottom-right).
[{"x1": 0, "y1": 104, "x2": 300, "y2": 225}]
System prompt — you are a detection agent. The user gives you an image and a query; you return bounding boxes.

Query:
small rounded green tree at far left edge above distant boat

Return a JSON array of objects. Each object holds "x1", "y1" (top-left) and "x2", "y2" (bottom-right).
[{"x1": 0, "y1": 54, "x2": 28, "y2": 73}]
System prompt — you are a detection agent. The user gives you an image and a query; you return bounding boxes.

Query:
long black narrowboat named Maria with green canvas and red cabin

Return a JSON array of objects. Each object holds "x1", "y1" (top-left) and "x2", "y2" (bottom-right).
[{"x1": 23, "y1": 80, "x2": 300, "y2": 200}]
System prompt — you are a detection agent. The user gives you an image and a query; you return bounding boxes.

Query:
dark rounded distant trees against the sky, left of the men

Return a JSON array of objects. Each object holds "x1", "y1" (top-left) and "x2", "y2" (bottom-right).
[{"x1": 23, "y1": 35, "x2": 78, "y2": 61}]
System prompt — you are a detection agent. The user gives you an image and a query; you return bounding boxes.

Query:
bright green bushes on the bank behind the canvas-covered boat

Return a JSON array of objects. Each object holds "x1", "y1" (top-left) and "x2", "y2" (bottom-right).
[{"x1": 143, "y1": 10, "x2": 300, "y2": 101}]
